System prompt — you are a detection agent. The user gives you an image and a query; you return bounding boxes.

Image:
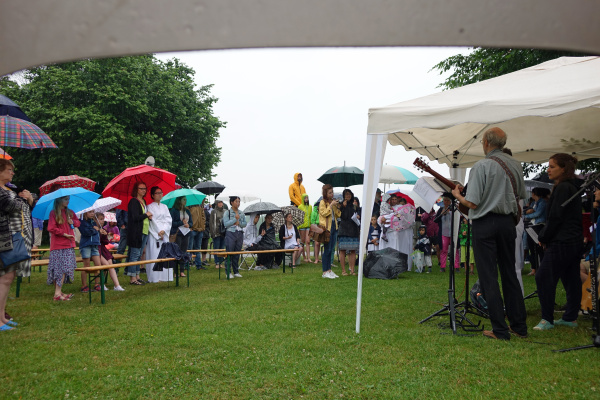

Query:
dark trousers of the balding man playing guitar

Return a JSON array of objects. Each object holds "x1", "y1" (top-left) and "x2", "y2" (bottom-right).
[{"x1": 473, "y1": 214, "x2": 527, "y2": 339}]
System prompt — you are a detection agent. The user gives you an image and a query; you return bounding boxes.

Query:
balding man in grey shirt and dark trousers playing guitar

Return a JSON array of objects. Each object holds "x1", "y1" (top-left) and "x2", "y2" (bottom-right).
[{"x1": 452, "y1": 128, "x2": 527, "y2": 340}]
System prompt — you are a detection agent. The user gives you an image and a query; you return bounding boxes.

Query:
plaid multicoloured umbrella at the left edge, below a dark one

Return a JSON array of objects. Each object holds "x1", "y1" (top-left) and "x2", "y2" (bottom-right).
[{"x1": 0, "y1": 115, "x2": 58, "y2": 149}]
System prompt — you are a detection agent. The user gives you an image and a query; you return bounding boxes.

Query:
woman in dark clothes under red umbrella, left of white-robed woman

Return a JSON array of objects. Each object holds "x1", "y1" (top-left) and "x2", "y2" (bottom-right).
[{"x1": 125, "y1": 182, "x2": 152, "y2": 285}]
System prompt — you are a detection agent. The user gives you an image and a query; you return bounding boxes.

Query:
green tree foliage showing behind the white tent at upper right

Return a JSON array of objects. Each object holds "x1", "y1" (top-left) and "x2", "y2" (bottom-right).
[{"x1": 433, "y1": 47, "x2": 600, "y2": 176}]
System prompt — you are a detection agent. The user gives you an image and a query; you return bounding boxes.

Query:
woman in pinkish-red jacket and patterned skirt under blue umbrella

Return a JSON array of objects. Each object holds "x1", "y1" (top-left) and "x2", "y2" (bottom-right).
[{"x1": 47, "y1": 196, "x2": 80, "y2": 301}]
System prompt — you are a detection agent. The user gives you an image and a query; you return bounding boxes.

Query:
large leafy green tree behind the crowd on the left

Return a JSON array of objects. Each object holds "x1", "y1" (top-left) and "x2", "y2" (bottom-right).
[{"x1": 0, "y1": 55, "x2": 225, "y2": 188}]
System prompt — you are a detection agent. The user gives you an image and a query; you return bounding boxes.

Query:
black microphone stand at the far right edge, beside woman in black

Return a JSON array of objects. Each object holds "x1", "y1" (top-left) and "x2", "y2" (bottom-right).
[{"x1": 554, "y1": 172, "x2": 600, "y2": 353}]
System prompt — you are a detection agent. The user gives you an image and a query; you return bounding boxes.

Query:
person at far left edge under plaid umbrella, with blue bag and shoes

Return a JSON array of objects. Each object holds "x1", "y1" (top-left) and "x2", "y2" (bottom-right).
[{"x1": 0, "y1": 158, "x2": 33, "y2": 331}]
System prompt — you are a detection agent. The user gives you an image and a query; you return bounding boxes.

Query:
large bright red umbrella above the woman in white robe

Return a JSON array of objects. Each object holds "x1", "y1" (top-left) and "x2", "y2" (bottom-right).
[{"x1": 102, "y1": 165, "x2": 177, "y2": 210}]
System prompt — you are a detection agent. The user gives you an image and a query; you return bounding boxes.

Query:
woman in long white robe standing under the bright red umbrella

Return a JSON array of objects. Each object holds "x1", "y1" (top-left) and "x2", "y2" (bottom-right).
[{"x1": 146, "y1": 186, "x2": 173, "y2": 283}]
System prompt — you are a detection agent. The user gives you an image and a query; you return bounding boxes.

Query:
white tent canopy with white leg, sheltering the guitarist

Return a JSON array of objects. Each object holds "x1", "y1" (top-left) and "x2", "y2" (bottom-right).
[{"x1": 356, "y1": 57, "x2": 600, "y2": 332}]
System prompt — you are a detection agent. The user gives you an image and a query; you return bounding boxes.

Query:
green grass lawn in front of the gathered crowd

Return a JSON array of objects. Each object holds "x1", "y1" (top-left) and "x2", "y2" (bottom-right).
[{"x1": 0, "y1": 264, "x2": 600, "y2": 399}]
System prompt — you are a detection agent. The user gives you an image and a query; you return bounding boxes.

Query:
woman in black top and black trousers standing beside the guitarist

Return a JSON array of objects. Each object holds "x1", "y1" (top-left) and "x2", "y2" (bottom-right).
[{"x1": 533, "y1": 153, "x2": 583, "y2": 330}]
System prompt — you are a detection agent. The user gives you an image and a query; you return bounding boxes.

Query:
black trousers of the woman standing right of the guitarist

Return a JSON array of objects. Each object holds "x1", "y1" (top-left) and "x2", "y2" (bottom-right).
[{"x1": 535, "y1": 243, "x2": 581, "y2": 324}]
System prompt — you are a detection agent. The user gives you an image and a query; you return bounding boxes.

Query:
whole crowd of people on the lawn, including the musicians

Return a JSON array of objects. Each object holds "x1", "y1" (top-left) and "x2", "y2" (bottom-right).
[{"x1": 0, "y1": 128, "x2": 600, "y2": 340}]
